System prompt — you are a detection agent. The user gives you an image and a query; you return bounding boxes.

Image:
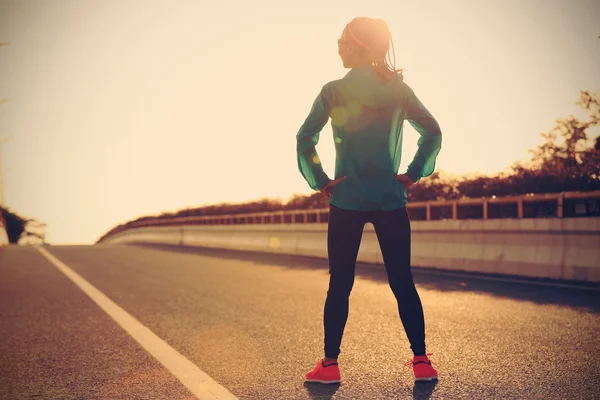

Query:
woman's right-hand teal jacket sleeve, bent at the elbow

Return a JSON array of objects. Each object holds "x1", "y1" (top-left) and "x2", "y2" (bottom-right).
[{"x1": 404, "y1": 84, "x2": 442, "y2": 182}]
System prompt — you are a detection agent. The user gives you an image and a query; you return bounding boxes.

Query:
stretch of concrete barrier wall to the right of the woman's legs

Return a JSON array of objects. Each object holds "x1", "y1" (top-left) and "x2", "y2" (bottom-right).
[{"x1": 413, "y1": 218, "x2": 600, "y2": 282}]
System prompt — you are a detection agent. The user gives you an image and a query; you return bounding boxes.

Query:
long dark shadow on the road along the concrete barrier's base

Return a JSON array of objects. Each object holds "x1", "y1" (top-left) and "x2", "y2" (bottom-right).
[{"x1": 138, "y1": 245, "x2": 600, "y2": 313}]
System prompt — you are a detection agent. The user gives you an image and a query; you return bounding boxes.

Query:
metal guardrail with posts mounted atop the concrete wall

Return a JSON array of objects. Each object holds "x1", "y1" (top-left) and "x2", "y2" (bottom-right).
[{"x1": 104, "y1": 190, "x2": 600, "y2": 238}]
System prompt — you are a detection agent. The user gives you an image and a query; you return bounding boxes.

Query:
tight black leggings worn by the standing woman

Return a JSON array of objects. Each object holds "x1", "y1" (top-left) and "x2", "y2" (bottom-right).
[{"x1": 323, "y1": 205, "x2": 425, "y2": 358}]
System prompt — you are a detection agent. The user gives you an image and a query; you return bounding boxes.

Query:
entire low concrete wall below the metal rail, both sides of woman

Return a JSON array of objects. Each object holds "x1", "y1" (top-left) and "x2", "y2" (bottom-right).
[{"x1": 103, "y1": 218, "x2": 600, "y2": 282}]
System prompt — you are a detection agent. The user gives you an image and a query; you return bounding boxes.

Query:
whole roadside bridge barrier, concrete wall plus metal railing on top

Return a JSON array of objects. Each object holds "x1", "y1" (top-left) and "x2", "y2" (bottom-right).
[{"x1": 100, "y1": 191, "x2": 600, "y2": 282}]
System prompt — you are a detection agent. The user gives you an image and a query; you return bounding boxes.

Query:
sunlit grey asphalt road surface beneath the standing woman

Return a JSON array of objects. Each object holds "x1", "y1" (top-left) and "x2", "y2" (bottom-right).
[{"x1": 0, "y1": 245, "x2": 600, "y2": 400}]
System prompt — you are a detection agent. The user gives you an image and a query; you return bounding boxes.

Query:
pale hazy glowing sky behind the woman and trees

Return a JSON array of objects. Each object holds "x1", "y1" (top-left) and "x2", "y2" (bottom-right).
[{"x1": 0, "y1": 0, "x2": 600, "y2": 244}]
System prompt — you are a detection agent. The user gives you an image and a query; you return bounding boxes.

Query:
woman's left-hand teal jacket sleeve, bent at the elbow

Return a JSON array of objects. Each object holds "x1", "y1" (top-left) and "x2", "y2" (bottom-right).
[{"x1": 296, "y1": 85, "x2": 331, "y2": 190}]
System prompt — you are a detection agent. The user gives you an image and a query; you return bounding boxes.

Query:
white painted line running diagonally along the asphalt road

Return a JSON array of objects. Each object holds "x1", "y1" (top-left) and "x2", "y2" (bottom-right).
[{"x1": 36, "y1": 246, "x2": 237, "y2": 400}]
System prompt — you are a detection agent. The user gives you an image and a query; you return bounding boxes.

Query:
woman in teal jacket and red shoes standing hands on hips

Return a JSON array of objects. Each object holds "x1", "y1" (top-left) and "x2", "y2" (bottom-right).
[{"x1": 296, "y1": 17, "x2": 442, "y2": 383}]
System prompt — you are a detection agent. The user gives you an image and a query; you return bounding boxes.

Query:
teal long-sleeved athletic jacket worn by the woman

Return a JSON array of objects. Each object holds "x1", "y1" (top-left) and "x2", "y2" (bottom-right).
[{"x1": 296, "y1": 65, "x2": 442, "y2": 210}]
